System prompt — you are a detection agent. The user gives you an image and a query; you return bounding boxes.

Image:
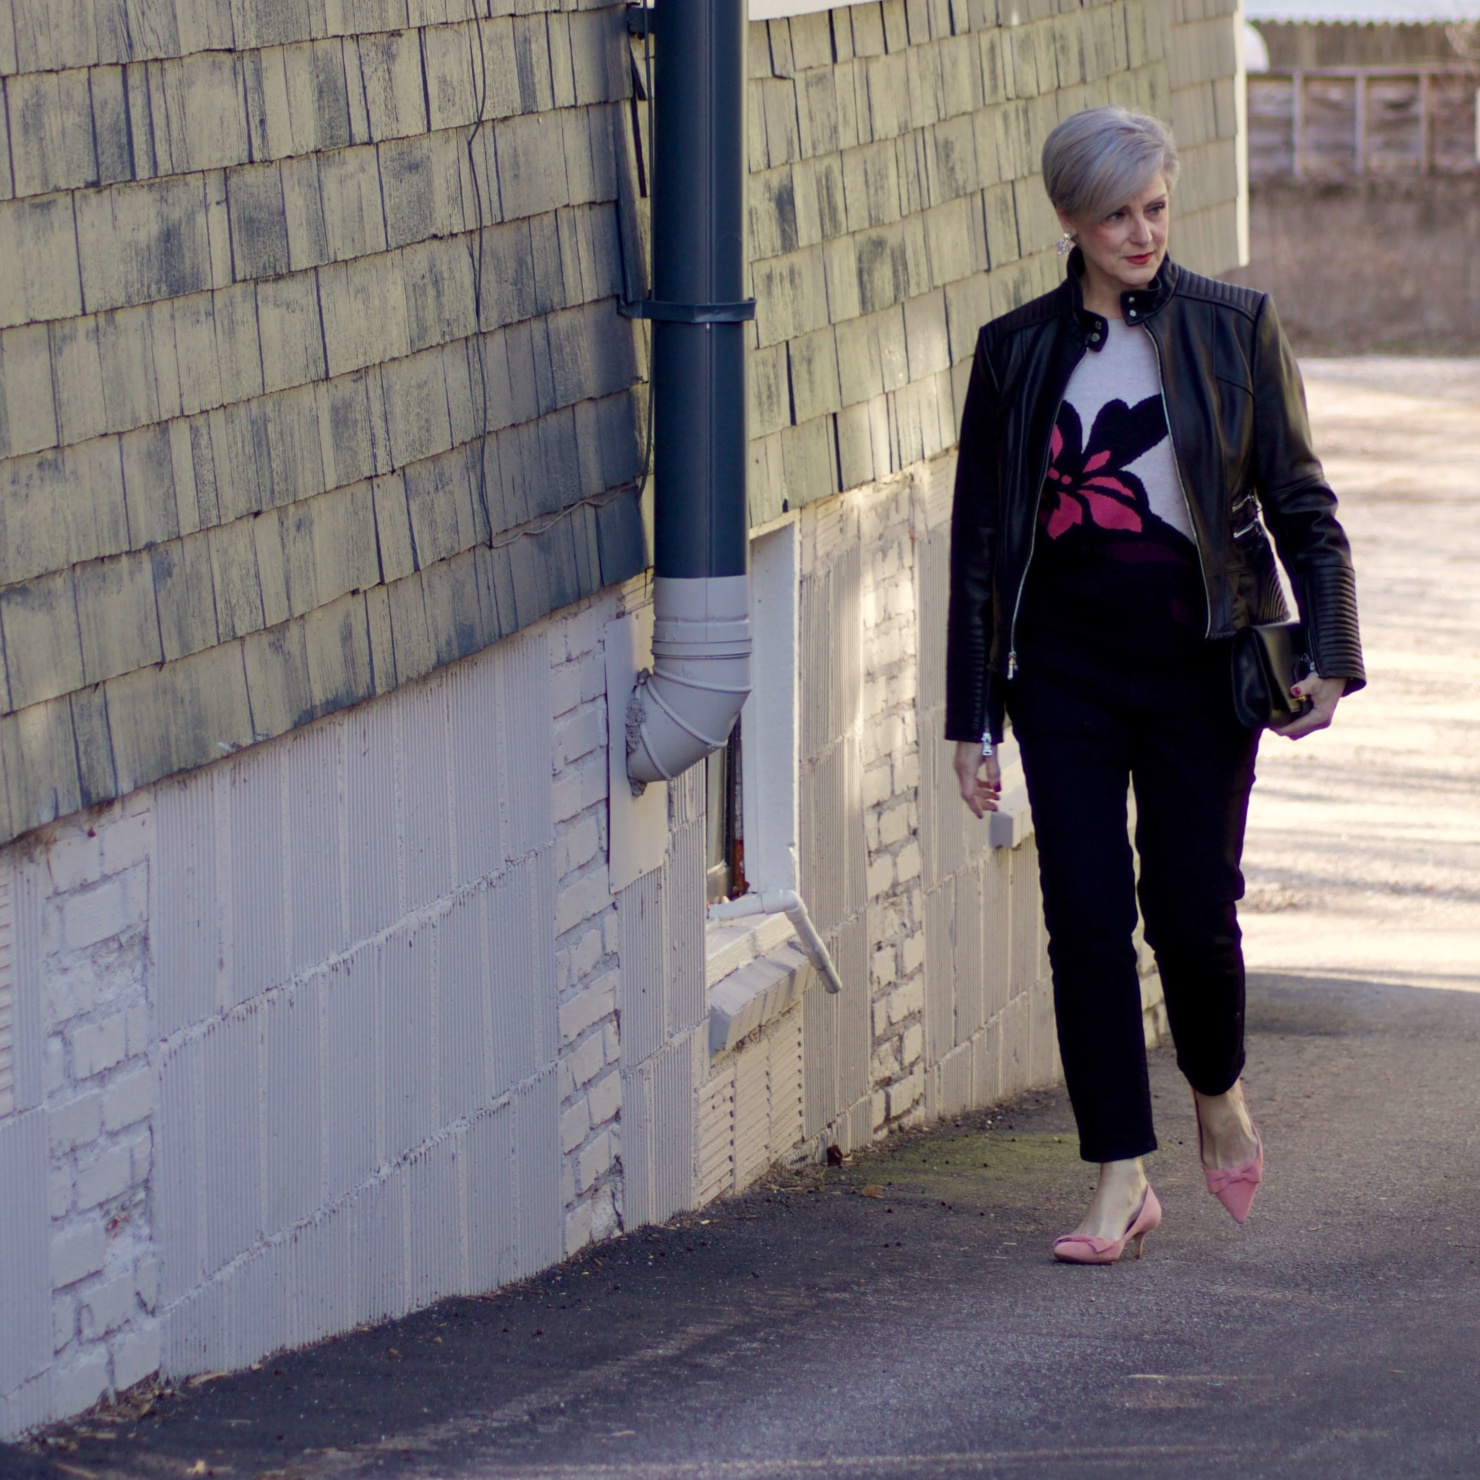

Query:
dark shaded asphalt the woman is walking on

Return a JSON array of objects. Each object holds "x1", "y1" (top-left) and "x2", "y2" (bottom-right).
[{"x1": 11, "y1": 977, "x2": 1480, "y2": 1480}]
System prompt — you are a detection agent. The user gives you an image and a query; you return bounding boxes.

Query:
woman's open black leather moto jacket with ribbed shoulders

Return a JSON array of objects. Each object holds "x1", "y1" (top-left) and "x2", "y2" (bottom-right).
[{"x1": 946, "y1": 249, "x2": 1366, "y2": 740}]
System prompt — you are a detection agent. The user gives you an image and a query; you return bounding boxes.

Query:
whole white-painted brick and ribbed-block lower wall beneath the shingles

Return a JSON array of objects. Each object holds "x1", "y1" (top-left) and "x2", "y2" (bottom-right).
[{"x1": 0, "y1": 455, "x2": 1095, "y2": 1428}]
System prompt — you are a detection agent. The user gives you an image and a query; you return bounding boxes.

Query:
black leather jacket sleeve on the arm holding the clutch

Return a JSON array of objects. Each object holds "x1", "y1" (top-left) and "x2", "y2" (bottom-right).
[{"x1": 1254, "y1": 297, "x2": 1366, "y2": 694}]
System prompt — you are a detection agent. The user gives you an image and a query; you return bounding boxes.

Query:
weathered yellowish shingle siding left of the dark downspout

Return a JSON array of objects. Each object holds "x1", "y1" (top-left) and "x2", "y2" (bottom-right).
[{"x1": 0, "y1": 0, "x2": 644, "y2": 836}]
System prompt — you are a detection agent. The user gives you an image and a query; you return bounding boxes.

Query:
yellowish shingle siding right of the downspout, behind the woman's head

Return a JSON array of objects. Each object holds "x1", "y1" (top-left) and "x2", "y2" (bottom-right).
[{"x1": 750, "y1": 0, "x2": 1239, "y2": 522}]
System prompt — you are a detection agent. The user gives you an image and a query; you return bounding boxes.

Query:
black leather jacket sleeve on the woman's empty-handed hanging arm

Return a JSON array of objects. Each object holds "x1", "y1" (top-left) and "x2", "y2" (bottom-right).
[{"x1": 946, "y1": 334, "x2": 1002, "y2": 740}]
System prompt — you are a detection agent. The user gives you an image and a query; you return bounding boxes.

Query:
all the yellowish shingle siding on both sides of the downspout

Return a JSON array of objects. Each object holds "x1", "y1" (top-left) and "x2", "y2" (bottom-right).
[{"x1": 0, "y1": 0, "x2": 1236, "y2": 838}]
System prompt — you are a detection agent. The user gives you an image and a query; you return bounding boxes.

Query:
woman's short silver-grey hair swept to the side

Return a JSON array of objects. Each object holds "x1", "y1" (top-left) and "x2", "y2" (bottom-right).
[{"x1": 1043, "y1": 108, "x2": 1178, "y2": 221}]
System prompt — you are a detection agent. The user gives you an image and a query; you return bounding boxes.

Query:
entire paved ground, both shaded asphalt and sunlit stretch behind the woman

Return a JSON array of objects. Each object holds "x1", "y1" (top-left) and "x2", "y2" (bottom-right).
[{"x1": 0, "y1": 361, "x2": 1480, "y2": 1480}]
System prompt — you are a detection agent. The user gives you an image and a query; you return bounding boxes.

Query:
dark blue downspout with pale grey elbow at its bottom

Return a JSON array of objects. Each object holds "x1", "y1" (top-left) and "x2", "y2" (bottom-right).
[{"x1": 628, "y1": 0, "x2": 755, "y2": 786}]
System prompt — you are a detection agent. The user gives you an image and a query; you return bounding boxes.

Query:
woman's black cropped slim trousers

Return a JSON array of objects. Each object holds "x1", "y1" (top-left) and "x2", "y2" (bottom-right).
[{"x1": 1008, "y1": 663, "x2": 1259, "y2": 1162}]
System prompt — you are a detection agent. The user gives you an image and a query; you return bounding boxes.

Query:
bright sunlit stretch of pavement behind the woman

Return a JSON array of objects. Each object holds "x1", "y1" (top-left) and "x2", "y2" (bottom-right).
[{"x1": 1243, "y1": 360, "x2": 1480, "y2": 990}]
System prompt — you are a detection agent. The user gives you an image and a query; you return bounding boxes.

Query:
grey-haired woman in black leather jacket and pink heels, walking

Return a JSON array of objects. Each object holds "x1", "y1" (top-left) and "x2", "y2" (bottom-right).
[{"x1": 946, "y1": 108, "x2": 1365, "y2": 1264}]
